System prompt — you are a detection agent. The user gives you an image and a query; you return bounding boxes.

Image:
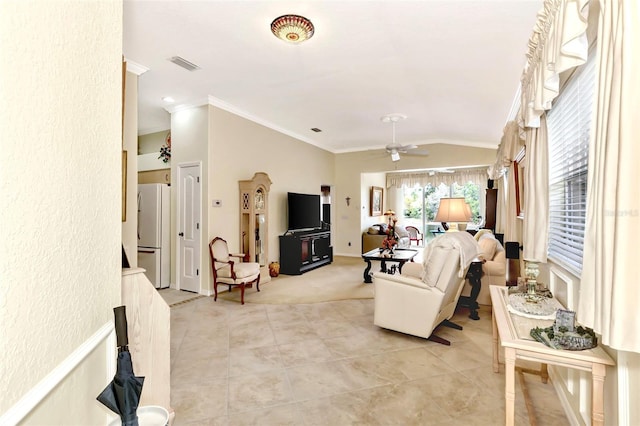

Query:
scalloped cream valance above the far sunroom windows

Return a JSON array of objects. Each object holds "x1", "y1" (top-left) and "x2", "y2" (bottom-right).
[{"x1": 387, "y1": 167, "x2": 489, "y2": 188}]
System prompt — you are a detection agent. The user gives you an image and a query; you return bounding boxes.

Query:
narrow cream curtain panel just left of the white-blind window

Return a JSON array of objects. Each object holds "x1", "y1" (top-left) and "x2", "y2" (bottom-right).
[{"x1": 521, "y1": 114, "x2": 549, "y2": 263}]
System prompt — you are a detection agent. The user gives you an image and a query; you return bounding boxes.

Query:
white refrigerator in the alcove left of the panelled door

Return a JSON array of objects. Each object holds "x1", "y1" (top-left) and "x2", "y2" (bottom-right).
[{"x1": 138, "y1": 183, "x2": 171, "y2": 288}]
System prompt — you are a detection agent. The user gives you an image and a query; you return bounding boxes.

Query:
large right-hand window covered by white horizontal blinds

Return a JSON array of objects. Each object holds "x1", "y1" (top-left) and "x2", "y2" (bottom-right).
[{"x1": 547, "y1": 52, "x2": 595, "y2": 275}]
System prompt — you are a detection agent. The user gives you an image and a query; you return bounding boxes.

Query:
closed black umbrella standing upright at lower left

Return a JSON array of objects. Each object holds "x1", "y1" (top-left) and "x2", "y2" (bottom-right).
[{"x1": 97, "y1": 306, "x2": 144, "y2": 426}]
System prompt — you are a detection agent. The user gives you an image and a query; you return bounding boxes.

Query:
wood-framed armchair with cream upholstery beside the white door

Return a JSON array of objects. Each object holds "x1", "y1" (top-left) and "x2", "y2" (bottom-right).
[{"x1": 209, "y1": 237, "x2": 260, "y2": 305}]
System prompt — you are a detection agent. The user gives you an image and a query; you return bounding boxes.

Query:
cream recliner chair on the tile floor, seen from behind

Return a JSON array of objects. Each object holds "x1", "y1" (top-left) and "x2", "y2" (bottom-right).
[{"x1": 373, "y1": 232, "x2": 478, "y2": 345}]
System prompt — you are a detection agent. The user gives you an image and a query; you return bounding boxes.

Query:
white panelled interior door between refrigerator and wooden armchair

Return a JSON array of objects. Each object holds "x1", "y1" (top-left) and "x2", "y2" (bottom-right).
[{"x1": 177, "y1": 164, "x2": 202, "y2": 293}]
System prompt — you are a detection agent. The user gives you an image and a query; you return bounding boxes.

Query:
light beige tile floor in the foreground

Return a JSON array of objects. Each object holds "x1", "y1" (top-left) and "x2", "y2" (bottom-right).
[{"x1": 171, "y1": 297, "x2": 568, "y2": 426}]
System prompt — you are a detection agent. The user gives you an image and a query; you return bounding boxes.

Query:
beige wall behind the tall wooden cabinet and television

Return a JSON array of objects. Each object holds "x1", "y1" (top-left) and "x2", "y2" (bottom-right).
[{"x1": 205, "y1": 107, "x2": 334, "y2": 292}]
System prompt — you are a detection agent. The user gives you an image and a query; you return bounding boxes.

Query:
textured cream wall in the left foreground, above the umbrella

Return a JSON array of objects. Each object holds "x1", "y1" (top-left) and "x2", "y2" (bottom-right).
[{"x1": 0, "y1": 0, "x2": 122, "y2": 424}]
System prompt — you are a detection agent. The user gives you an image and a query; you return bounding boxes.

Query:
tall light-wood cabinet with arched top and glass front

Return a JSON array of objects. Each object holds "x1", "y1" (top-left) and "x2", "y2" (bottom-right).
[{"x1": 239, "y1": 172, "x2": 271, "y2": 277}]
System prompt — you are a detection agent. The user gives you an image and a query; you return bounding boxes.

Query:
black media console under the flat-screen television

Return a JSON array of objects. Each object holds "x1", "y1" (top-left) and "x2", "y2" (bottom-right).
[{"x1": 280, "y1": 229, "x2": 333, "y2": 275}]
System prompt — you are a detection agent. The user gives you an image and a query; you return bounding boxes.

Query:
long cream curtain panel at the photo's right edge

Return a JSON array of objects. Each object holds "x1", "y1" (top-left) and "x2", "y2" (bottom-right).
[{"x1": 578, "y1": 0, "x2": 640, "y2": 352}]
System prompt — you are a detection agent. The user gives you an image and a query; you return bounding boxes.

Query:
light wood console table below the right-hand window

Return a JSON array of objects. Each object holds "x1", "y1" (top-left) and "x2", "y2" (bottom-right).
[{"x1": 490, "y1": 285, "x2": 615, "y2": 426}]
